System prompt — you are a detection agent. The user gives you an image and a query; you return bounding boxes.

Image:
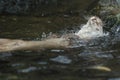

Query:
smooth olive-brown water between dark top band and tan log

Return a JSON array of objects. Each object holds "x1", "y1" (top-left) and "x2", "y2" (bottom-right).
[{"x1": 0, "y1": 16, "x2": 83, "y2": 39}]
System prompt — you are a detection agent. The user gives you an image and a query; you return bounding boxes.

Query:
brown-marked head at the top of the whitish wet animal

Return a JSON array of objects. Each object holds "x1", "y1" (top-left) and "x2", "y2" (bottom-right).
[{"x1": 87, "y1": 16, "x2": 103, "y2": 27}]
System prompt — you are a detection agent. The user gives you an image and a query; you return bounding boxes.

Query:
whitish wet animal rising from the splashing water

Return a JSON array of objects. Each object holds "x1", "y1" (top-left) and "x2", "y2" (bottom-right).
[{"x1": 75, "y1": 16, "x2": 103, "y2": 39}]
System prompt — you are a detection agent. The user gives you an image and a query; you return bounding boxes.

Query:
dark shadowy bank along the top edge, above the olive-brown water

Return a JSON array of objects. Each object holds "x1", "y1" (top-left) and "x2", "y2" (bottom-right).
[{"x1": 0, "y1": 0, "x2": 99, "y2": 16}]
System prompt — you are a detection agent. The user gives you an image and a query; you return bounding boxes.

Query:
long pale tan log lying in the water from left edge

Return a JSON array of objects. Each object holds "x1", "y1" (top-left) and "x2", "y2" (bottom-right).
[{"x1": 0, "y1": 38, "x2": 70, "y2": 52}]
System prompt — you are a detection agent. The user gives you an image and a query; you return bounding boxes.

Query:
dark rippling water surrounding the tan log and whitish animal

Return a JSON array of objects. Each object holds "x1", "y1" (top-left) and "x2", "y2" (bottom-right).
[{"x1": 0, "y1": 0, "x2": 120, "y2": 80}]
